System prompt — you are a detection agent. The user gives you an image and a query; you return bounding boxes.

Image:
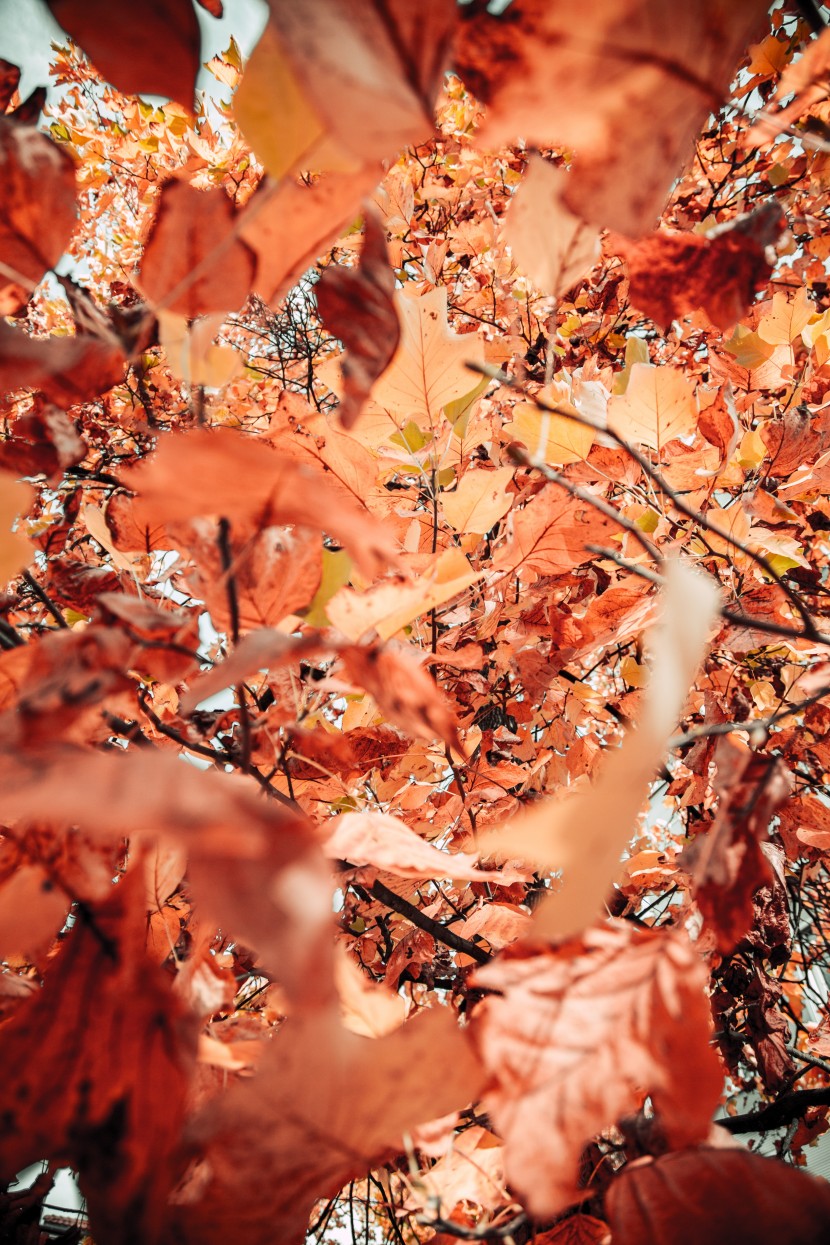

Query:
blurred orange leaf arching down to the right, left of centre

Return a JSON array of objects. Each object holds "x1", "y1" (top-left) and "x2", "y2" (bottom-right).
[{"x1": 122, "y1": 428, "x2": 398, "y2": 579}]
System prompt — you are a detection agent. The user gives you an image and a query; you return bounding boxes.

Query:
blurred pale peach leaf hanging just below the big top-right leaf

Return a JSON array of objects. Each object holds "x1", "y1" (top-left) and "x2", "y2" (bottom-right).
[{"x1": 504, "y1": 153, "x2": 600, "y2": 298}]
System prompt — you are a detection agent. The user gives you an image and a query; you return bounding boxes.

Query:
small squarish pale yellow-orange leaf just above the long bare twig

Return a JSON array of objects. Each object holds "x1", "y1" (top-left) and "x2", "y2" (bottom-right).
[{"x1": 609, "y1": 364, "x2": 697, "y2": 453}]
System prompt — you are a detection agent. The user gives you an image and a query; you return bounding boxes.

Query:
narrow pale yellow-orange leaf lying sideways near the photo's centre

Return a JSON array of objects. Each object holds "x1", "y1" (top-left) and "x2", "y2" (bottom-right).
[{"x1": 326, "y1": 549, "x2": 482, "y2": 640}]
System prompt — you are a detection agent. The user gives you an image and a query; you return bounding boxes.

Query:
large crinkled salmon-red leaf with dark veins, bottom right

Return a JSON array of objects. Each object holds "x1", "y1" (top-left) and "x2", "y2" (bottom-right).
[{"x1": 473, "y1": 921, "x2": 722, "y2": 1218}]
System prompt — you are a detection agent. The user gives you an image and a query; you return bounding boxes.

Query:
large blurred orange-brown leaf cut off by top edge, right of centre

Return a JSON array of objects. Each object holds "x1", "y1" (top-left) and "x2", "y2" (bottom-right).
[{"x1": 454, "y1": 0, "x2": 767, "y2": 238}]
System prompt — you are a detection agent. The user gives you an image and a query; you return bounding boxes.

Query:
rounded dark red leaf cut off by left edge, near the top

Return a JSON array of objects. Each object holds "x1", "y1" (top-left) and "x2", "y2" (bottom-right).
[{"x1": 0, "y1": 117, "x2": 77, "y2": 315}]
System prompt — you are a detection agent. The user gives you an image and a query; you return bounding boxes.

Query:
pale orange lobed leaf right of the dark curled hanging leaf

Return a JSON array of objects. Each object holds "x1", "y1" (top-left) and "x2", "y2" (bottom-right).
[{"x1": 371, "y1": 286, "x2": 484, "y2": 428}]
